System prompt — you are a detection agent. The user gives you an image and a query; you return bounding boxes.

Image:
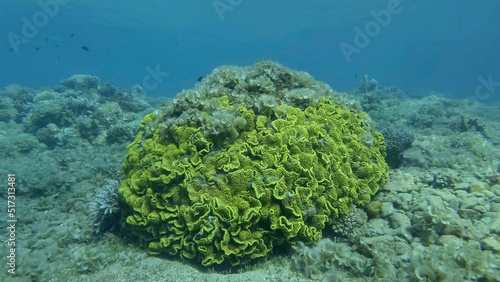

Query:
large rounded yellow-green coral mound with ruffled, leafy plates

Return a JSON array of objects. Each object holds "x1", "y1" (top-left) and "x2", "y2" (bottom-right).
[{"x1": 119, "y1": 61, "x2": 388, "y2": 266}]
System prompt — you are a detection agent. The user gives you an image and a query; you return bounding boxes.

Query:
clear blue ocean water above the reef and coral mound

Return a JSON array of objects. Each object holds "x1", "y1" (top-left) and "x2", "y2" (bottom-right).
[{"x1": 0, "y1": 0, "x2": 500, "y2": 100}]
